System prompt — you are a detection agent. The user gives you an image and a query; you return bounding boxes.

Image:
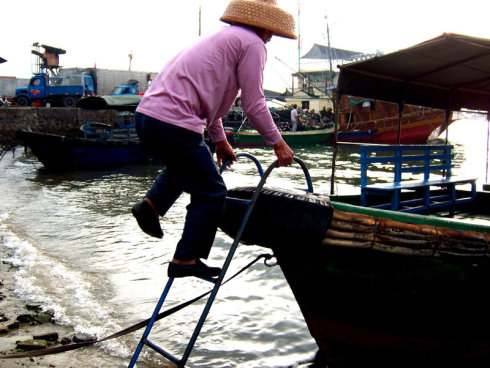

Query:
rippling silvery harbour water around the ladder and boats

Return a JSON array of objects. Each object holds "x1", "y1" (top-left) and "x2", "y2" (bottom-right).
[{"x1": 0, "y1": 119, "x2": 487, "y2": 368}]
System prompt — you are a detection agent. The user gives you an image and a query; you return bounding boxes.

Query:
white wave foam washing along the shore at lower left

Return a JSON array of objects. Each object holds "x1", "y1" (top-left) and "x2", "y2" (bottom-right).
[{"x1": 0, "y1": 213, "x2": 134, "y2": 357}]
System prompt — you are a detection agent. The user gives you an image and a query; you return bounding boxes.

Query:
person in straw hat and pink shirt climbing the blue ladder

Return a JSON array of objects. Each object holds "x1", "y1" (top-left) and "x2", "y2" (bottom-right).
[{"x1": 132, "y1": 0, "x2": 296, "y2": 277}]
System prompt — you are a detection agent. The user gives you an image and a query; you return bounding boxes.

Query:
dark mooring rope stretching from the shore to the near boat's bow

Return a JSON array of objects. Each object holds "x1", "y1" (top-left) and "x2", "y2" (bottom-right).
[{"x1": 0, "y1": 253, "x2": 274, "y2": 359}]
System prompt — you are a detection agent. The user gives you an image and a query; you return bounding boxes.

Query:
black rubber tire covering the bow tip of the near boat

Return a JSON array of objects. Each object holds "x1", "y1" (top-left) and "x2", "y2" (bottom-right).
[{"x1": 219, "y1": 187, "x2": 333, "y2": 248}]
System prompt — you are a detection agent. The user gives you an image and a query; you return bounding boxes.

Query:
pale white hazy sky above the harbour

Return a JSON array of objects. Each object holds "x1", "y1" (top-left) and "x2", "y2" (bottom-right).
[{"x1": 0, "y1": 0, "x2": 490, "y2": 91}]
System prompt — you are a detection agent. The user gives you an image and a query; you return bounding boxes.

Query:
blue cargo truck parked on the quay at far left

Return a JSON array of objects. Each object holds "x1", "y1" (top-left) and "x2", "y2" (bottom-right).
[{"x1": 14, "y1": 73, "x2": 97, "y2": 107}]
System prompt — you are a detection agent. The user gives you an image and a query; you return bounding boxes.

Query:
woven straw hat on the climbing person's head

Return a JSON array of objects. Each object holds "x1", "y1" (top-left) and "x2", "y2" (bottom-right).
[{"x1": 220, "y1": 0, "x2": 297, "y2": 38}]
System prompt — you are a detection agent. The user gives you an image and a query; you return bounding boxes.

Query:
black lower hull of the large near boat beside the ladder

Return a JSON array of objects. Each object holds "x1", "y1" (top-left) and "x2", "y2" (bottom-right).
[{"x1": 274, "y1": 229, "x2": 490, "y2": 367}]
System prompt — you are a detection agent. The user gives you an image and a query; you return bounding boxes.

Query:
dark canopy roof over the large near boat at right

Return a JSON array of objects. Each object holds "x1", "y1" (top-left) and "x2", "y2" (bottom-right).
[{"x1": 337, "y1": 33, "x2": 490, "y2": 112}]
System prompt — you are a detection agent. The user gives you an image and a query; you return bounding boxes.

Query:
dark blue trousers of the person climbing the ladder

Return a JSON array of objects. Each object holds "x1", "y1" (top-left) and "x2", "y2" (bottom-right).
[{"x1": 134, "y1": 113, "x2": 226, "y2": 261}]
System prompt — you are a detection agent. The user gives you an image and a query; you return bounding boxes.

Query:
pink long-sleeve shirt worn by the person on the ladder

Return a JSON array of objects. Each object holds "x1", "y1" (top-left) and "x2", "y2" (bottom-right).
[{"x1": 136, "y1": 25, "x2": 281, "y2": 145}]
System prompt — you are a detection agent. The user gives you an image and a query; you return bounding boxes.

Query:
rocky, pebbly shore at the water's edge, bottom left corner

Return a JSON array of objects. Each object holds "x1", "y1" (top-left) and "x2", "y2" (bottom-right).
[{"x1": 0, "y1": 256, "x2": 105, "y2": 368}]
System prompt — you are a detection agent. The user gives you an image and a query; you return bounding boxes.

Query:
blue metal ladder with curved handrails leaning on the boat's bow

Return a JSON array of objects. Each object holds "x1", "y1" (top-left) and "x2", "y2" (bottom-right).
[{"x1": 128, "y1": 153, "x2": 313, "y2": 368}]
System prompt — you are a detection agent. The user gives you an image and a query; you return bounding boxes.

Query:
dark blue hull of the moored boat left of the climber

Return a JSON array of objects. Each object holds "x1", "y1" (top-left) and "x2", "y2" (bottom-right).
[{"x1": 17, "y1": 131, "x2": 151, "y2": 170}]
